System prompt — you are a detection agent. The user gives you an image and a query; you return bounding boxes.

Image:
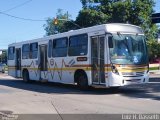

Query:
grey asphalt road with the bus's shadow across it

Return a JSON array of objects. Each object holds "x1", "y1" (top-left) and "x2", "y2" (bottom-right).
[{"x1": 0, "y1": 74, "x2": 160, "y2": 118}]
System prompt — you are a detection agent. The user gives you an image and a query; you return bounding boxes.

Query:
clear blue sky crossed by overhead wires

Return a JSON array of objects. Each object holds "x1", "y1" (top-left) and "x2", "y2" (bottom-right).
[{"x1": 0, "y1": 0, "x2": 160, "y2": 49}]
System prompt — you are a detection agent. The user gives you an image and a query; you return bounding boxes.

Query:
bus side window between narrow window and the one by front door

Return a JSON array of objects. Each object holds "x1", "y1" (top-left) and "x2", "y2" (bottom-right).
[{"x1": 52, "y1": 38, "x2": 68, "y2": 57}]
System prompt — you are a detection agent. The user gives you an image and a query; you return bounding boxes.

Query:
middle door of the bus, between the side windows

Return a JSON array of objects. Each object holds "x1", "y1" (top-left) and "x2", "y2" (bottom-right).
[{"x1": 38, "y1": 45, "x2": 48, "y2": 80}]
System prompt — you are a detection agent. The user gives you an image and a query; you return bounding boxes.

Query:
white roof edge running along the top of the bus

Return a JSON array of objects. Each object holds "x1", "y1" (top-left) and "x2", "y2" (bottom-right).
[{"x1": 9, "y1": 23, "x2": 143, "y2": 46}]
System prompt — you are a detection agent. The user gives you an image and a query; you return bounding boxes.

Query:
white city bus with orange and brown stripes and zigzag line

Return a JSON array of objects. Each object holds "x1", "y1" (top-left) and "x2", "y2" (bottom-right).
[{"x1": 8, "y1": 24, "x2": 149, "y2": 87}]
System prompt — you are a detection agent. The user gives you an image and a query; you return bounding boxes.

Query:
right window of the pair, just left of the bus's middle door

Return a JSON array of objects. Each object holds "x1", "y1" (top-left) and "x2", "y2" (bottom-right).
[{"x1": 30, "y1": 42, "x2": 38, "y2": 59}]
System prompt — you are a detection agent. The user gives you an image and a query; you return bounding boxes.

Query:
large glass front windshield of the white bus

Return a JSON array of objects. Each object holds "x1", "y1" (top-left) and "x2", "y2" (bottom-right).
[{"x1": 110, "y1": 34, "x2": 148, "y2": 65}]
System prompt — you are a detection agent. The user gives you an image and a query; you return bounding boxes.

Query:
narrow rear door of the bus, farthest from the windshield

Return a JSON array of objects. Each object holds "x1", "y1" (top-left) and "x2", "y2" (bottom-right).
[{"x1": 15, "y1": 48, "x2": 22, "y2": 77}]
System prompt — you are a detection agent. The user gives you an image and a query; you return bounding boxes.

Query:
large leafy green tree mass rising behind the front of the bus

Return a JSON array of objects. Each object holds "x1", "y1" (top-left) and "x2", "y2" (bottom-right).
[{"x1": 76, "y1": 0, "x2": 157, "y2": 40}]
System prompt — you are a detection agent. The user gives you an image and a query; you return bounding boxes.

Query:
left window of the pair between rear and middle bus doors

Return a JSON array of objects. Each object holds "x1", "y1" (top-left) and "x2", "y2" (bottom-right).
[{"x1": 22, "y1": 44, "x2": 30, "y2": 59}]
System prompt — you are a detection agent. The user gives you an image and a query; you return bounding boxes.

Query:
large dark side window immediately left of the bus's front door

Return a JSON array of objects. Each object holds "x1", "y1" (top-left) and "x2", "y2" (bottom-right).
[{"x1": 68, "y1": 34, "x2": 88, "y2": 56}]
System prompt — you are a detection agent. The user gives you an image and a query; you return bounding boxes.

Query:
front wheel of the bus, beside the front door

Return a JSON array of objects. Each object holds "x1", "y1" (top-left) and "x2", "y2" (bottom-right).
[{"x1": 77, "y1": 74, "x2": 88, "y2": 90}]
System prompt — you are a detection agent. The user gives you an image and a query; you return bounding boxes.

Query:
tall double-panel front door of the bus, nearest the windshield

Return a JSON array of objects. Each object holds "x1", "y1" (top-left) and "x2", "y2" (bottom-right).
[{"x1": 91, "y1": 35, "x2": 105, "y2": 84}]
